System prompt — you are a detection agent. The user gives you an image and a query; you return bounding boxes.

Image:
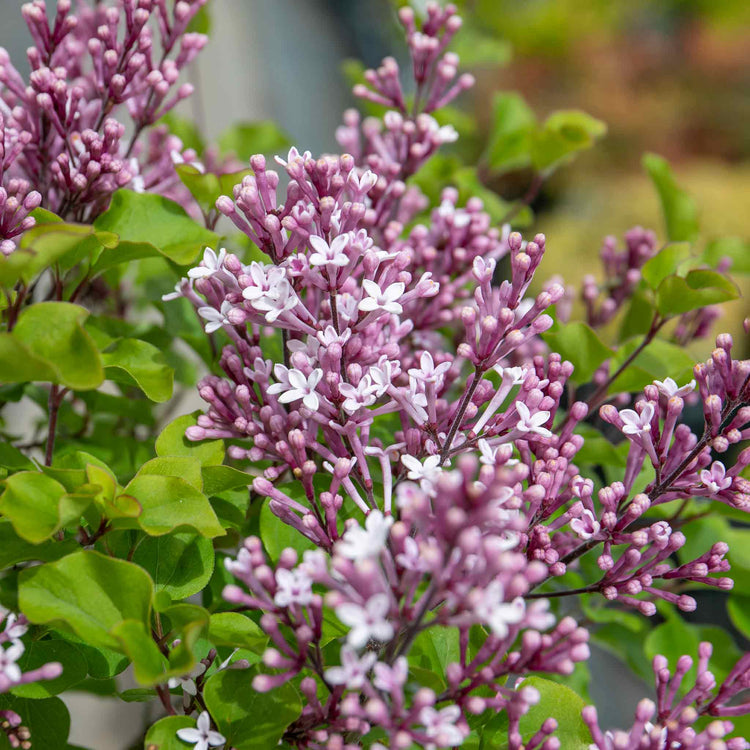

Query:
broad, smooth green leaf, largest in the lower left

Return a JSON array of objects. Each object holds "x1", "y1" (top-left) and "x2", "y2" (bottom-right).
[{"x1": 18, "y1": 551, "x2": 153, "y2": 651}]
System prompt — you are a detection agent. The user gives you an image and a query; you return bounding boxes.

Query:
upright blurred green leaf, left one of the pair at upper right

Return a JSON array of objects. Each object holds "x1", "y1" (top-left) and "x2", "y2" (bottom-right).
[{"x1": 487, "y1": 91, "x2": 536, "y2": 172}]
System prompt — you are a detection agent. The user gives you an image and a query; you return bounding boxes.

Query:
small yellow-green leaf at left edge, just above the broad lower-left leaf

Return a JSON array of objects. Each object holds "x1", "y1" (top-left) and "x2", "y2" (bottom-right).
[{"x1": 0, "y1": 471, "x2": 93, "y2": 544}]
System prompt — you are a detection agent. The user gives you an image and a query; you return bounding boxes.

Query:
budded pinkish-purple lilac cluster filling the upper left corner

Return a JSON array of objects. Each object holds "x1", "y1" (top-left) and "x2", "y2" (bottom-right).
[{"x1": 0, "y1": 0, "x2": 206, "y2": 239}]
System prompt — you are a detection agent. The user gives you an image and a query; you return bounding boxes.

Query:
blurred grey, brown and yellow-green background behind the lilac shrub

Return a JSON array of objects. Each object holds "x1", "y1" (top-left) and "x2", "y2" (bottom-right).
[{"x1": 0, "y1": 0, "x2": 750, "y2": 750}]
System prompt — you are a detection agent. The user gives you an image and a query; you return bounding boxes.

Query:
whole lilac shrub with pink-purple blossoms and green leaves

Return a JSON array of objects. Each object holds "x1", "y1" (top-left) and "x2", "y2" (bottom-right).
[{"x1": 0, "y1": 0, "x2": 750, "y2": 750}]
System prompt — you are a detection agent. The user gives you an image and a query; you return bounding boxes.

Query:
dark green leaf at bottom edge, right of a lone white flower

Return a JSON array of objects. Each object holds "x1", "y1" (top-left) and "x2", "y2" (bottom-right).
[{"x1": 203, "y1": 669, "x2": 302, "y2": 750}]
